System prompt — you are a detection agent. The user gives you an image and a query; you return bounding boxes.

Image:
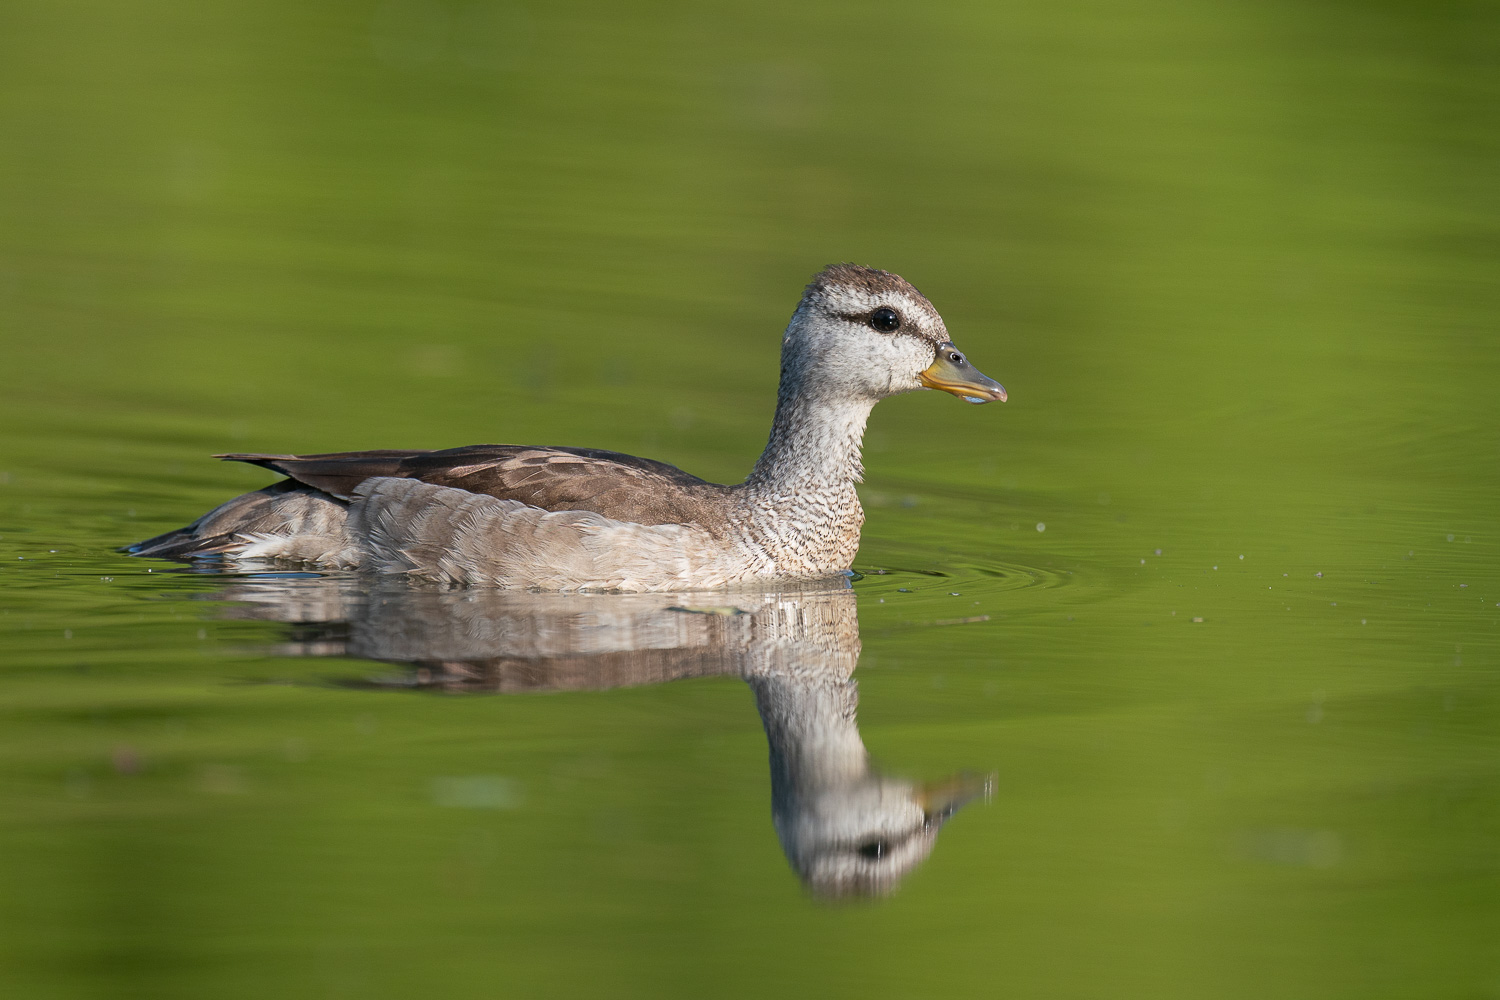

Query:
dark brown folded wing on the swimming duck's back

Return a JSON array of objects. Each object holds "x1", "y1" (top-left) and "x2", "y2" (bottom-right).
[{"x1": 218, "y1": 444, "x2": 731, "y2": 525}]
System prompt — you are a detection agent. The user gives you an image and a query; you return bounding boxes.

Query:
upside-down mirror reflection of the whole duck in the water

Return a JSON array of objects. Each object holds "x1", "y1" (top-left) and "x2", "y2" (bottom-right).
[{"x1": 211, "y1": 576, "x2": 989, "y2": 898}]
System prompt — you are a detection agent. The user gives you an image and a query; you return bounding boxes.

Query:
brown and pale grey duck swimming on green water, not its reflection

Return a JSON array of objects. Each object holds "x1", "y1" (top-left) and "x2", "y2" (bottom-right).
[{"x1": 131, "y1": 264, "x2": 1005, "y2": 591}]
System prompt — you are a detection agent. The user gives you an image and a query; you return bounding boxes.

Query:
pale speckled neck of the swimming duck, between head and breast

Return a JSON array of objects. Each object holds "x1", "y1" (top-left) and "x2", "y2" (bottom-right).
[{"x1": 747, "y1": 379, "x2": 875, "y2": 493}]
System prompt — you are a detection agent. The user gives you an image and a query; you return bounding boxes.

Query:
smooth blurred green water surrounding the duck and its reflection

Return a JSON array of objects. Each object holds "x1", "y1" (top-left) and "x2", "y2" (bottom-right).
[{"x1": 0, "y1": 0, "x2": 1500, "y2": 999}]
